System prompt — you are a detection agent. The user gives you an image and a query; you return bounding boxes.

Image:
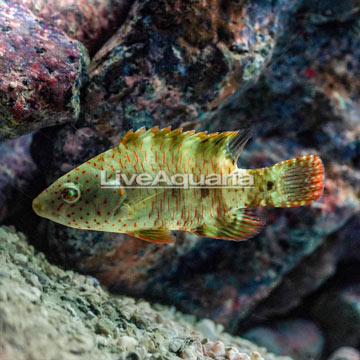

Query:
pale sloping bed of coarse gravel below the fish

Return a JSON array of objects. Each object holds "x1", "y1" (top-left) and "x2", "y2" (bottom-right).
[{"x1": 0, "y1": 227, "x2": 291, "y2": 360}]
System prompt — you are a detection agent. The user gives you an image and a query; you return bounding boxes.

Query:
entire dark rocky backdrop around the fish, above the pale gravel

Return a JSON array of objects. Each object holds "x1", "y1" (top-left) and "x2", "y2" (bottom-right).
[{"x1": 0, "y1": 0, "x2": 360, "y2": 360}]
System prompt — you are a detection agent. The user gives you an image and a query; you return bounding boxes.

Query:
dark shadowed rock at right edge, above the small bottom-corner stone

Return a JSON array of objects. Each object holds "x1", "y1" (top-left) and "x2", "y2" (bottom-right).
[{"x1": 311, "y1": 283, "x2": 360, "y2": 351}]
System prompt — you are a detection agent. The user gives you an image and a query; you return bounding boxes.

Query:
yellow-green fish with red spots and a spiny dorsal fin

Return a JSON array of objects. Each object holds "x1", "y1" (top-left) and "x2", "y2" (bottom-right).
[{"x1": 32, "y1": 127, "x2": 324, "y2": 244}]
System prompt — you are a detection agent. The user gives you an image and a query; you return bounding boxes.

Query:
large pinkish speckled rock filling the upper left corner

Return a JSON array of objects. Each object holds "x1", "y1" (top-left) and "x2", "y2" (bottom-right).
[{"x1": 0, "y1": 0, "x2": 87, "y2": 140}]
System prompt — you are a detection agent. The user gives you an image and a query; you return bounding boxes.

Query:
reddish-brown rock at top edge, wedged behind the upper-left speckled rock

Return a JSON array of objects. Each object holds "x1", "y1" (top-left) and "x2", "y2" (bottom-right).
[{"x1": 22, "y1": 0, "x2": 133, "y2": 55}]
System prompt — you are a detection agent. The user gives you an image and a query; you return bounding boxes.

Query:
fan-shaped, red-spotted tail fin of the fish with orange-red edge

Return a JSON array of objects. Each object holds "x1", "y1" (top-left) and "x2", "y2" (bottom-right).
[{"x1": 269, "y1": 155, "x2": 324, "y2": 207}]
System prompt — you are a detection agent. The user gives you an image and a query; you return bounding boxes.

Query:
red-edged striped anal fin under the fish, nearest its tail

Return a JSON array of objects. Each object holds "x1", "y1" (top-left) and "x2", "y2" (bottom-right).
[{"x1": 194, "y1": 209, "x2": 264, "y2": 241}]
